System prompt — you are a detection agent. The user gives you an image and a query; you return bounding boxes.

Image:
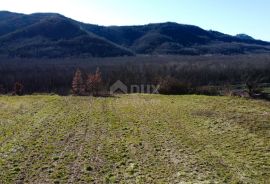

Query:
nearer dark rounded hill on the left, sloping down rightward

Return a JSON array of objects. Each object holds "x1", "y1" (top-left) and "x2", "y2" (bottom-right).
[{"x1": 0, "y1": 11, "x2": 133, "y2": 58}]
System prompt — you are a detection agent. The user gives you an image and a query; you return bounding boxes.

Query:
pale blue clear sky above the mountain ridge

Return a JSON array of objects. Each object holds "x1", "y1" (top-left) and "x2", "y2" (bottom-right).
[{"x1": 0, "y1": 0, "x2": 270, "y2": 41}]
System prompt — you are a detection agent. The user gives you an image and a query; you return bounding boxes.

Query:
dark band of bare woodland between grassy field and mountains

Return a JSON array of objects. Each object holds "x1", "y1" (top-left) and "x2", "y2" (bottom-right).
[{"x1": 0, "y1": 55, "x2": 270, "y2": 95}]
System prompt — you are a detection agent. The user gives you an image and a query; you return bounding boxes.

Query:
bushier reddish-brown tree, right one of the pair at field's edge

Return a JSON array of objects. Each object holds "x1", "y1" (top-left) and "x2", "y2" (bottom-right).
[{"x1": 86, "y1": 68, "x2": 102, "y2": 96}]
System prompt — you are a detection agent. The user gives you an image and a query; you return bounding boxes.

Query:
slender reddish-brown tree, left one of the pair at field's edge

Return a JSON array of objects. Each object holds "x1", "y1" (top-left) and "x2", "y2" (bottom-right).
[{"x1": 72, "y1": 69, "x2": 85, "y2": 95}]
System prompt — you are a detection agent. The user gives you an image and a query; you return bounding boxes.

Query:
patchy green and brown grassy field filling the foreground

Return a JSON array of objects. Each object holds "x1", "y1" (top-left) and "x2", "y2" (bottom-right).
[{"x1": 0, "y1": 95, "x2": 270, "y2": 184}]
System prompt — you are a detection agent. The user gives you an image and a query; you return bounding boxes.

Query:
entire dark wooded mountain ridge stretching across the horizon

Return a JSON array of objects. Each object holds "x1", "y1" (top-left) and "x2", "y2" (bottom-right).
[{"x1": 0, "y1": 11, "x2": 270, "y2": 58}]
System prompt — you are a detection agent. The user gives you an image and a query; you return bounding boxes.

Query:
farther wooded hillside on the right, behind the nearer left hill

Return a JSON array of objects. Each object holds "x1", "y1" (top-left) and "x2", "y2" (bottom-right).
[{"x1": 85, "y1": 22, "x2": 270, "y2": 55}]
